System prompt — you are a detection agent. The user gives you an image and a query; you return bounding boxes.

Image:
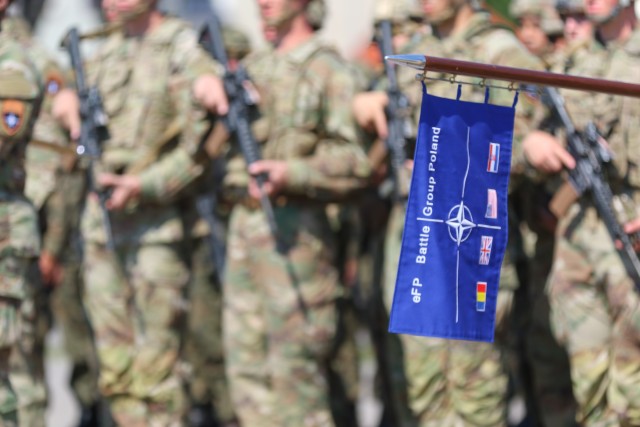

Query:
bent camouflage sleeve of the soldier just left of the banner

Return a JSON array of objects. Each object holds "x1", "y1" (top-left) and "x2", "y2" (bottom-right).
[{"x1": 287, "y1": 62, "x2": 371, "y2": 199}]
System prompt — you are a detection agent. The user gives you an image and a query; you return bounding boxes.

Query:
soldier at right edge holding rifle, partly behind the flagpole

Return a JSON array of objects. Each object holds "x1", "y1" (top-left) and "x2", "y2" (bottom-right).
[{"x1": 524, "y1": 0, "x2": 640, "y2": 426}]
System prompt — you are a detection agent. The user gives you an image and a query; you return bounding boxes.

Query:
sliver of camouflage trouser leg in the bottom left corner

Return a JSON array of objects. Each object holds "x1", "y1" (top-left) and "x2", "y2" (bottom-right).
[{"x1": 0, "y1": 297, "x2": 21, "y2": 427}]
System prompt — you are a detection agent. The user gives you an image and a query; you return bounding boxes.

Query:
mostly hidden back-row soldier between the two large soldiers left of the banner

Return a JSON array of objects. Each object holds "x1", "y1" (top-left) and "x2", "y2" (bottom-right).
[{"x1": 183, "y1": 27, "x2": 251, "y2": 427}]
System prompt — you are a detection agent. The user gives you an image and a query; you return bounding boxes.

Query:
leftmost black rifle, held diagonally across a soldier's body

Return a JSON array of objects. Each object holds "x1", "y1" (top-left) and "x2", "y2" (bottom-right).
[{"x1": 62, "y1": 28, "x2": 115, "y2": 251}]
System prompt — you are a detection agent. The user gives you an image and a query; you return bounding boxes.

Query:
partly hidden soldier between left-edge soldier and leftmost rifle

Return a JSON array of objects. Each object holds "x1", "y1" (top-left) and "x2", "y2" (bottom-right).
[{"x1": 3, "y1": 16, "x2": 104, "y2": 426}]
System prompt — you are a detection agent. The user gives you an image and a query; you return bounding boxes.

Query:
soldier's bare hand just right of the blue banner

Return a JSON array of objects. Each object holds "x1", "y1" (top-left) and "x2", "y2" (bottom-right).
[{"x1": 522, "y1": 131, "x2": 576, "y2": 173}]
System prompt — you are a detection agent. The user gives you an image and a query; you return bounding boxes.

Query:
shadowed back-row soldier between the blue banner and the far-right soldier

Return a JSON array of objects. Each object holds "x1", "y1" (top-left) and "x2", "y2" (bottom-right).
[{"x1": 511, "y1": 0, "x2": 575, "y2": 426}]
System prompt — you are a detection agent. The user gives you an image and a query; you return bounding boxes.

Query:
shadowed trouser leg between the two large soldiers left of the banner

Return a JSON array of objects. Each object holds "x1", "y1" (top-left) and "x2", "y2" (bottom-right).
[{"x1": 183, "y1": 239, "x2": 235, "y2": 423}]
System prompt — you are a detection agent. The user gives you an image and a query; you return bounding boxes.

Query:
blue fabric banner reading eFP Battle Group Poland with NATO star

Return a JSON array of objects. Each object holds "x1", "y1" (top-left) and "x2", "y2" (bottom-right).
[{"x1": 389, "y1": 88, "x2": 515, "y2": 342}]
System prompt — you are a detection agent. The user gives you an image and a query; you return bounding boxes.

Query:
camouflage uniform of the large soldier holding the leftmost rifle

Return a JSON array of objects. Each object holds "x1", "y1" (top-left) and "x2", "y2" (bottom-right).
[{"x1": 82, "y1": 17, "x2": 218, "y2": 425}]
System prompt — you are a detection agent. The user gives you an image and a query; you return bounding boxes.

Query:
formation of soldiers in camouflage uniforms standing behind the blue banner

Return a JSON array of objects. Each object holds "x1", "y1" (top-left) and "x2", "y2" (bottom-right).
[{"x1": 0, "y1": 0, "x2": 640, "y2": 427}]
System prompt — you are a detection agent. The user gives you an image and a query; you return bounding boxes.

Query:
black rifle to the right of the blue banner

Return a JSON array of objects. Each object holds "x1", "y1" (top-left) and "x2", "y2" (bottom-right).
[{"x1": 543, "y1": 86, "x2": 640, "y2": 292}]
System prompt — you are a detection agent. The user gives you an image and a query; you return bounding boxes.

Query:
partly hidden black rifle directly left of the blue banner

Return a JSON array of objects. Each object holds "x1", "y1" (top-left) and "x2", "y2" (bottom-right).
[{"x1": 376, "y1": 20, "x2": 409, "y2": 200}]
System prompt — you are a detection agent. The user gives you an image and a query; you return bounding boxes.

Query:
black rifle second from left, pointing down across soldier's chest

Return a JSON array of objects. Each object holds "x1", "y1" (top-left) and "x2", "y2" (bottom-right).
[{"x1": 200, "y1": 14, "x2": 278, "y2": 242}]
